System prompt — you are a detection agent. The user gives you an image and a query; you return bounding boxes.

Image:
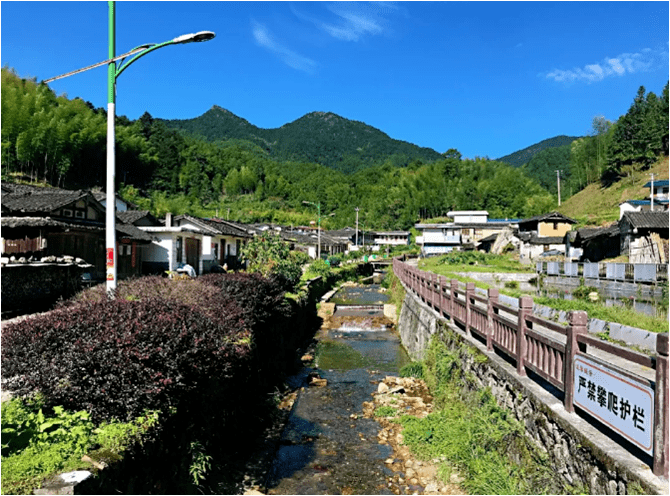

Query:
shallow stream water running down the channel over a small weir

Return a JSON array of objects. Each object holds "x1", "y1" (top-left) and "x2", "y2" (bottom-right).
[{"x1": 266, "y1": 286, "x2": 410, "y2": 494}]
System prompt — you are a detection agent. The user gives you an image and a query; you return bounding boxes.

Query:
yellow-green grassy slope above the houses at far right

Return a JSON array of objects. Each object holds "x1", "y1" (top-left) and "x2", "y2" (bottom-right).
[{"x1": 558, "y1": 156, "x2": 669, "y2": 226}]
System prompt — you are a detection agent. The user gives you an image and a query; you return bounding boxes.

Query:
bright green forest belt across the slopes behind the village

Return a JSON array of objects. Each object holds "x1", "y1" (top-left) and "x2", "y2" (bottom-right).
[{"x1": 0, "y1": 67, "x2": 670, "y2": 229}]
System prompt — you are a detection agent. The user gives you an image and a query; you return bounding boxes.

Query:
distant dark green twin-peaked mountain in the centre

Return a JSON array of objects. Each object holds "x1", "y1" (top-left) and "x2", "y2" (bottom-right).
[{"x1": 161, "y1": 105, "x2": 442, "y2": 173}]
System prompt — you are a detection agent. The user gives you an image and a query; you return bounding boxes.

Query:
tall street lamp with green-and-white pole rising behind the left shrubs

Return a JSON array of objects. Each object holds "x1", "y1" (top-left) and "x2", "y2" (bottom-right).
[{"x1": 44, "y1": 0, "x2": 215, "y2": 296}]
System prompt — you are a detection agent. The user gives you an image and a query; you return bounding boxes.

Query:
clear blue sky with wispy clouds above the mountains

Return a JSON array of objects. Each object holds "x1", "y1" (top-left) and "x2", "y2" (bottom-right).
[{"x1": 0, "y1": 1, "x2": 670, "y2": 158}]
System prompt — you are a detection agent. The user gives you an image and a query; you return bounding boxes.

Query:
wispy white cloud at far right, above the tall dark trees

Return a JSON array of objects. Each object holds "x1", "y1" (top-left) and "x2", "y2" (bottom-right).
[{"x1": 540, "y1": 48, "x2": 667, "y2": 83}]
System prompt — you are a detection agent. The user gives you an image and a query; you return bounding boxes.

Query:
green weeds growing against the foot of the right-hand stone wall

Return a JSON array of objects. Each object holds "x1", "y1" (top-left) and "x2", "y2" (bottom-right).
[{"x1": 399, "y1": 338, "x2": 582, "y2": 494}]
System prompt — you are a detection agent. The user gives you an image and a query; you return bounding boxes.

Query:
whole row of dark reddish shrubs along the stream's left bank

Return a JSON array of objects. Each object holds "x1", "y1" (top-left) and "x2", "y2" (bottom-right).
[{"x1": 1, "y1": 274, "x2": 298, "y2": 421}]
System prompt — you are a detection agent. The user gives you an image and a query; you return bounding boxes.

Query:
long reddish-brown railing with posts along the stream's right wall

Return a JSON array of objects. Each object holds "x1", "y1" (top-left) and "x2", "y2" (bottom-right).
[{"x1": 393, "y1": 258, "x2": 669, "y2": 475}]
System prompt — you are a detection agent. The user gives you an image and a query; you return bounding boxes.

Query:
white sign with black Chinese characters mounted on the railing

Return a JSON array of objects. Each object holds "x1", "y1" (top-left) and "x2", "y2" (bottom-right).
[{"x1": 574, "y1": 354, "x2": 654, "y2": 454}]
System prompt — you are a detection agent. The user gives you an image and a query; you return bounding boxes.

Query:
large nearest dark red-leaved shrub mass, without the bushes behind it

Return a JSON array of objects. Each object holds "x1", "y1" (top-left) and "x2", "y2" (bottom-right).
[{"x1": 2, "y1": 295, "x2": 249, "y2": 420}]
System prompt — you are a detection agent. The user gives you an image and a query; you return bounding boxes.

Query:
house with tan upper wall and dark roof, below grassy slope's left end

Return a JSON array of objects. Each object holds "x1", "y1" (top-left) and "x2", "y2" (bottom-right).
[{"x1": 517, "y1": 212, "x2": 577, "y2": 260}]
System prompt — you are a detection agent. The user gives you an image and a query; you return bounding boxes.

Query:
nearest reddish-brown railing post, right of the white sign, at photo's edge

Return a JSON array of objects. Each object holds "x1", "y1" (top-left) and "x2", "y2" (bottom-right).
[{"x1": 653, "y1": 332, "x2": 670, "y2": 477}]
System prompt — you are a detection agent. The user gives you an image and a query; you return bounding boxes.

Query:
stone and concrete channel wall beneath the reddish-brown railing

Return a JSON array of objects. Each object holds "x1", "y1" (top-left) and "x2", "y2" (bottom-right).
[{"x1": 398, "y1": 287, "x2": 669, "y2": 494}]
